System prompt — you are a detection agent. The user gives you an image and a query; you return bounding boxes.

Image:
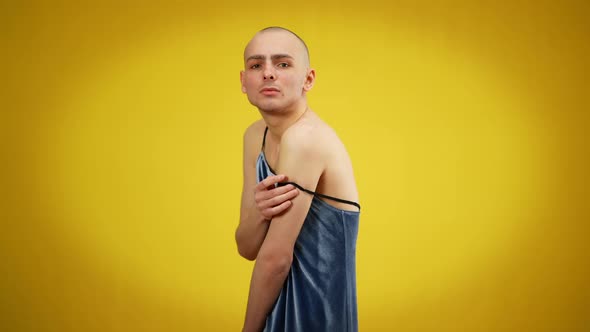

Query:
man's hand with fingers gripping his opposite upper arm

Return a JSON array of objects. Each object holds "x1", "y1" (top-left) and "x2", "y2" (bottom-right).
[{"x1": 254, "y1": 174, "x2": 299, "y2": 221}]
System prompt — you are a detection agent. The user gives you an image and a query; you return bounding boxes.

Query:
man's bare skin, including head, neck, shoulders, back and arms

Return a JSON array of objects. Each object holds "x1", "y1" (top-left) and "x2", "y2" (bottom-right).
[{"x1": 236, "y1": 29, "x2": 358, "y2": 331}]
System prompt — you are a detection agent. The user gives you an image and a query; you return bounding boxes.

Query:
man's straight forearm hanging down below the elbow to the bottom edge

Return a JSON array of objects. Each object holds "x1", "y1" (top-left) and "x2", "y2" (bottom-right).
[{"x1": 243, "y1": 258, "x2": 291, "y2": 332}]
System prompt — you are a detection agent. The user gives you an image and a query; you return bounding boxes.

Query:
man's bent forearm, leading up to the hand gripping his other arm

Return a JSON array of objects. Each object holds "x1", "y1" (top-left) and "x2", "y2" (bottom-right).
[{"x1": 236, "y1": 205, "x2": 269, "y2": 260}]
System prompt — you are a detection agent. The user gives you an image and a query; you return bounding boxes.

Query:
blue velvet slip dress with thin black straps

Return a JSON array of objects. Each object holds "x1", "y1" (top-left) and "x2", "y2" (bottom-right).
[{"x1": 256, "y1": 127, "x2": 360, "y2": 332}]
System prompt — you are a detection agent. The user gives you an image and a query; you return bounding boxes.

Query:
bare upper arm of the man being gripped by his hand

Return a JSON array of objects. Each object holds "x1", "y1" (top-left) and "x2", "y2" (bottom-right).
[{"x1": 259, "y1": 130, "x2": 324, "y2": 257}]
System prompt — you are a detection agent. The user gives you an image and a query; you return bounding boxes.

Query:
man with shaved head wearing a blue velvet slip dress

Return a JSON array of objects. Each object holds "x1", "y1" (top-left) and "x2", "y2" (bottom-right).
[{"x1": 236, "y1": 27, "x2": 360, "y2": 332}]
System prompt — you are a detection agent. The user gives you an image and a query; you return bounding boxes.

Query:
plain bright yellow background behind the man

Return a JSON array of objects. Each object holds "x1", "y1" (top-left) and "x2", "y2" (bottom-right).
[{"x1": 0, "y1": 1, "x2": 590, "y2": 331}]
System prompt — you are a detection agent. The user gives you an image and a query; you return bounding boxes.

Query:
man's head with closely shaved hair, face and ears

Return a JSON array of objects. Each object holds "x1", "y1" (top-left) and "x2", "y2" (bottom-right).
[{"x1": 240, "y1": 30, "x2": 315, "y2": 112}]
